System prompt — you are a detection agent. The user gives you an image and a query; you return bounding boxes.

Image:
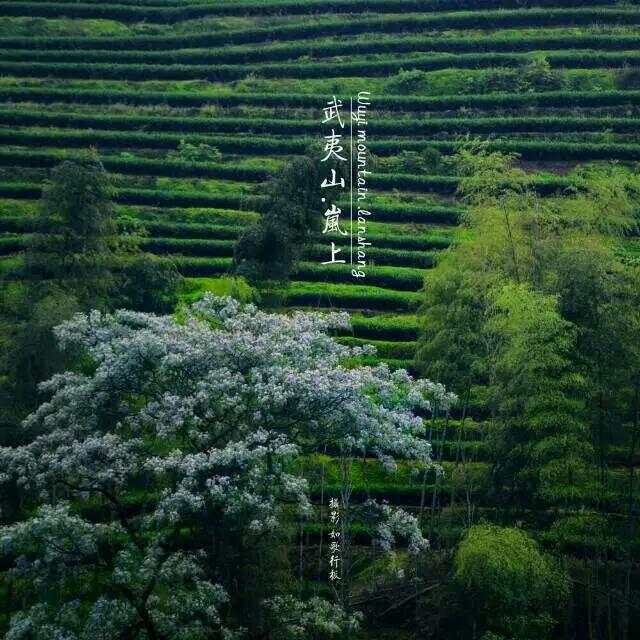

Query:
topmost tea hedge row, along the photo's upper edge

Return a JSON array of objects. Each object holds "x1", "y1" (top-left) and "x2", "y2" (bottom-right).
[{"x1": 3, "y1": 0, "x2": 616, "y2": 22}]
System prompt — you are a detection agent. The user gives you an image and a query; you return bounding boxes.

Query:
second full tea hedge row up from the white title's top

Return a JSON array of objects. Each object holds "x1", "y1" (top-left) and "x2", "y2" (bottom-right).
[{"x1": 0, "y1": 34, "x2": 640, "y2": 65}]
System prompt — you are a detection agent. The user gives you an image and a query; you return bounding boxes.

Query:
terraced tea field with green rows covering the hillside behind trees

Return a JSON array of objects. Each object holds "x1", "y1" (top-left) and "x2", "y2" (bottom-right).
[{"x1": 0, "y1": 0, "x2": 640, "y2": 376}]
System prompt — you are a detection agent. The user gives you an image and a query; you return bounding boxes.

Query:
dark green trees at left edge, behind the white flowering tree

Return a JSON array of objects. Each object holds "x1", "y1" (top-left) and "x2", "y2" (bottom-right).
[{"x1": 0, "y1": 156, "x2": 180, "y2": 438}]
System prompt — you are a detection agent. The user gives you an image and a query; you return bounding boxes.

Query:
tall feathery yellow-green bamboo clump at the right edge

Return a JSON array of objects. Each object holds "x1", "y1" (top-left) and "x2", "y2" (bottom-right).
[{"x1": 418, "y1": 141, "x2": 640, "y2": 635}]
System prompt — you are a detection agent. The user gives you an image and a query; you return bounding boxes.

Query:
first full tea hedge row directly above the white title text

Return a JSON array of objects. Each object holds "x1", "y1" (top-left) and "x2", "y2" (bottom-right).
[{"x1": 0, "y1": 50, "x2": 640, "y2": 82}]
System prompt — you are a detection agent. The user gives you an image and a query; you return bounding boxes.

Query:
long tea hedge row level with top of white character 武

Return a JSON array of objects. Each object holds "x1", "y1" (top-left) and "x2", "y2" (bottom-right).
[{"x1": 0, "y1": 87, "x2": 640, "y2": 112}]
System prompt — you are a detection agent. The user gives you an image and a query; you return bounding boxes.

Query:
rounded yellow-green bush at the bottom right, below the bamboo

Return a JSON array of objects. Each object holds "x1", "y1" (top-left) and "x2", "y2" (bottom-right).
[{"x1": 454, "y1": 525, "x2": 569, "y2": 640}]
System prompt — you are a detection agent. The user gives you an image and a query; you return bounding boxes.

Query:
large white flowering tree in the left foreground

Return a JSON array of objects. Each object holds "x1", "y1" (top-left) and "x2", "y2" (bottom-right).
[{"x1": 0, "y1": 296, "x2": 452, "y2": 640}]
